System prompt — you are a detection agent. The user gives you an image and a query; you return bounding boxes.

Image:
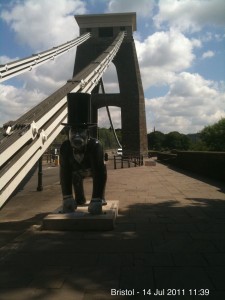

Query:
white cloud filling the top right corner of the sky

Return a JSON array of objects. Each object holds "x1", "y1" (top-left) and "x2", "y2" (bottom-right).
[{"x1": 154, "y1": 0, "x2": 225, "y2": 32}]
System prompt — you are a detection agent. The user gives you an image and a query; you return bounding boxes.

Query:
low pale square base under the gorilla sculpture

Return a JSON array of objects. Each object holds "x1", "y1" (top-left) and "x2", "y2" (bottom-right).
[{"x1": 42, "y1": 200, "x2": 119, "y2": 231}]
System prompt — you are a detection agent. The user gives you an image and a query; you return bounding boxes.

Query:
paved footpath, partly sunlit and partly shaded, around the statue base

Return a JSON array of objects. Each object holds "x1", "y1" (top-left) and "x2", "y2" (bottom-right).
[{"x1": 0, "y1": 158, "x2": 225, "y2": 300}]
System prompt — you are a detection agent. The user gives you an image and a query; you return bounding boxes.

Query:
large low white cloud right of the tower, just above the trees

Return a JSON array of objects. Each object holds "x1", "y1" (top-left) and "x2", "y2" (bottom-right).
[{"x1": 146, "y1": 72, "x2": 225, "y2": 133}]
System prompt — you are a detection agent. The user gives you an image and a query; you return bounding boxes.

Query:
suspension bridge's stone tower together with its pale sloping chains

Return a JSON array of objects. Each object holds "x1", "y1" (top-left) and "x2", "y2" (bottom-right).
[{"x1": 0, "y1": 13, "x2": 147, "y2": 207}]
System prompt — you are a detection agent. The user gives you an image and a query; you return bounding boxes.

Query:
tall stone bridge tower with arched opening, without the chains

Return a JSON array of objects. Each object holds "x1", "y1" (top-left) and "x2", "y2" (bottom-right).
[{"x1": 74, "y1": 13, "x2": 147, "y2": 155}]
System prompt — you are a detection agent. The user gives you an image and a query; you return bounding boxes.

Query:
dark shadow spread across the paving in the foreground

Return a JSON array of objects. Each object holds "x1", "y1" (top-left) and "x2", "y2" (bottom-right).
[{"x1": 0, "y1": 193, "x2": 225, "y2": 300}]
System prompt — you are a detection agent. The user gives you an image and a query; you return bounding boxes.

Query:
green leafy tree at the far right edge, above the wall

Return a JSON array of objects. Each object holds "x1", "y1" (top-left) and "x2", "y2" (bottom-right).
[{"x1": 200, "y1": 118, "x2": 225, "y2": 151}]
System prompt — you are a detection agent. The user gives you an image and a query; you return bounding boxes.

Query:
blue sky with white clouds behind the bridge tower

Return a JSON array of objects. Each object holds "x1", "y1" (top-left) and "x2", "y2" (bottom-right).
[{"x1": 0, "y1": 0, "x2": 225, "y2": 134}]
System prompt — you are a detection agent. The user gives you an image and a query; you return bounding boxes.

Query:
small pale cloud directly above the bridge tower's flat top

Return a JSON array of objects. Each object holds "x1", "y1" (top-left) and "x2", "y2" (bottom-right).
[{"x1": 107, "y1": 0, "x2": 154, "y2": 17}]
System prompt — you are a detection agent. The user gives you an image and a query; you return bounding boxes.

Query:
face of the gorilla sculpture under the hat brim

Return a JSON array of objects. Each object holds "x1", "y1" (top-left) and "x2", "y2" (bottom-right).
[{"x1": 69, "y1": 128, "x2": 88, "y2": 152}]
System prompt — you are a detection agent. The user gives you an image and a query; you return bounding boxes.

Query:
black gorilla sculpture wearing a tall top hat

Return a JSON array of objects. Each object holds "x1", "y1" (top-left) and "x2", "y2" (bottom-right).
[{"x1": 60, "y1": 93, "x2": 107, "y2": 214}]
